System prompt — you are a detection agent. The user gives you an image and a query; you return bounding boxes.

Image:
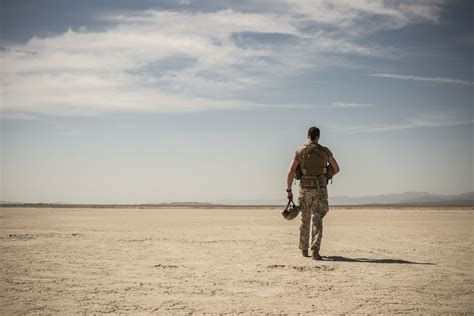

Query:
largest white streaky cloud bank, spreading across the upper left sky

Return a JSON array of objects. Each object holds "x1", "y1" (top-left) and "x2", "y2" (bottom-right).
[{"x1": 0, "y1": 1, "x2": 444, "y2": 115}]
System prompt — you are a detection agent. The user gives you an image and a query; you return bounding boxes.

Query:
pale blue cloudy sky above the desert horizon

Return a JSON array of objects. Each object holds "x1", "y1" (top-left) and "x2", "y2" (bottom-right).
[{"x1": 0, "y1": 0, "x2": 474, "y2": 203}]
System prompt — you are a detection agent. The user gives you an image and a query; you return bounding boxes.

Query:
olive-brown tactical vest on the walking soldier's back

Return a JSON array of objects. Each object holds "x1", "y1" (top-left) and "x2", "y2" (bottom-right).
[{"x1": 300, "y1": 143, "x2": 329, "y2": 188}]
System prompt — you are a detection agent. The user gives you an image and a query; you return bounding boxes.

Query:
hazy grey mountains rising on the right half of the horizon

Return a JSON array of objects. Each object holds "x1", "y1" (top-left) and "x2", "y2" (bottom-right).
[{"x1": 214, "y1": 192, "x2": 474, "y2": 206}]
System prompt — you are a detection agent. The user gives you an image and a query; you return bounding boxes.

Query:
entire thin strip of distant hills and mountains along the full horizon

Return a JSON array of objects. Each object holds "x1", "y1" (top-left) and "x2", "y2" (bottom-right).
[{"x1": 0, "y1": 192, "x2": 474, "y2": 208}]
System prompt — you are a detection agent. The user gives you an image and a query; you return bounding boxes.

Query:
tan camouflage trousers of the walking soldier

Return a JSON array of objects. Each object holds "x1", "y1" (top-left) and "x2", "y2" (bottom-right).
[{"x1": 298, "y1": 179, "x2": 329, "y2": 251}]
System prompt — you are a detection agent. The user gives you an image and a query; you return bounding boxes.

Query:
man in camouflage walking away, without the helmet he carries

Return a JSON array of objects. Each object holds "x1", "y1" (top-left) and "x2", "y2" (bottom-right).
[{"x1": 286, "y1": 126, "x2": 339, "y2": 260}]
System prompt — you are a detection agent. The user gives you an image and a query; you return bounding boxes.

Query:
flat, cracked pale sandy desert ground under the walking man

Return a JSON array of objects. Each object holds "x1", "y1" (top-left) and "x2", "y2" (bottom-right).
[{"x1": 0, "y1": 208, "x2": 474, "y2": 315}]
